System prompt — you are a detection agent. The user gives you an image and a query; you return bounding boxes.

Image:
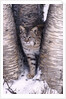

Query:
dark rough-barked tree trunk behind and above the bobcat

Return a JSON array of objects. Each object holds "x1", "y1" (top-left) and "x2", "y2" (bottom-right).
[{"x1": 12, "y1": 4, "x2": 43, "y2": 29}]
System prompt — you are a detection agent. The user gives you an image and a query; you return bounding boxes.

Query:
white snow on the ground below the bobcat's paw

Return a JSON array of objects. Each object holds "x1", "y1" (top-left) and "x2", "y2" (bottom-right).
[{"x1": 3, "y1": 68, "x2": 58, "y2": 94}]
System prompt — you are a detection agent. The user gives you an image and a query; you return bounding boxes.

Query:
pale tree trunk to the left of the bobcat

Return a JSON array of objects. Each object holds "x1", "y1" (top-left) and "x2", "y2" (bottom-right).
[{"x1": 3, "y1": 4, "x2": 23, "y2": 81}]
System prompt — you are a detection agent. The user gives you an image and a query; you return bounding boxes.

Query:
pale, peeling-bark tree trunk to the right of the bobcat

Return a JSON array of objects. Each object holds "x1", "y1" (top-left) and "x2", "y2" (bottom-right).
[{"x1": 39, "y1": 4, "x2": 63, "y2": 93}]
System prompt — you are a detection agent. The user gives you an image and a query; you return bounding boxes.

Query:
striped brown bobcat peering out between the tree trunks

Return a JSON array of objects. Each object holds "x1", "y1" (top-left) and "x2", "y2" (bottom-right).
[{"x1": 20, "y1": 26, "x2": 41, "y2": 78}]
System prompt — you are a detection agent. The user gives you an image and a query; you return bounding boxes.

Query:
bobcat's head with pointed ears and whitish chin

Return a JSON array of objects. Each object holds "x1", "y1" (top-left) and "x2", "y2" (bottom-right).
[{"x1": 19, "y1": 26, "x2": 41, "y2": 46}]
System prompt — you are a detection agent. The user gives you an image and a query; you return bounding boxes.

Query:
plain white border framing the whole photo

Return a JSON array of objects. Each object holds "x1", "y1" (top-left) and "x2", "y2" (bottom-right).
[{"x1": 0, "y1": 0, "x2": 66, "y2": 99}]
